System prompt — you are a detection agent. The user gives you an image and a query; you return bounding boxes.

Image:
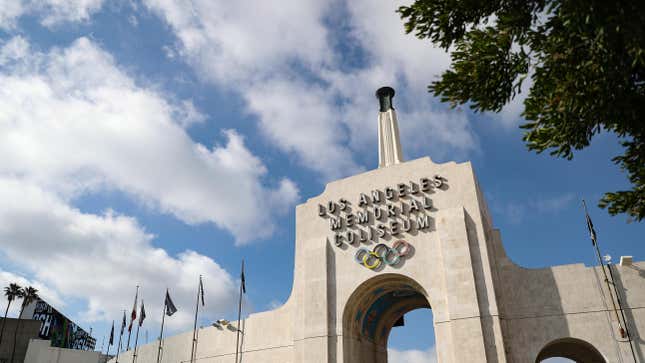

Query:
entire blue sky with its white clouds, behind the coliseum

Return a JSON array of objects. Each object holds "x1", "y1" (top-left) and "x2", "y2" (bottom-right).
[{"x1": 0, "y1": 0, "x2": 645, "y2": 362}]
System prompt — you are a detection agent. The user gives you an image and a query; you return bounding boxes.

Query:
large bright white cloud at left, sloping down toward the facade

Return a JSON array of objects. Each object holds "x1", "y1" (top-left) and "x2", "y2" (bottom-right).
[{"x1": 0, "y1": 38, "x2": 298, "y2": 243}]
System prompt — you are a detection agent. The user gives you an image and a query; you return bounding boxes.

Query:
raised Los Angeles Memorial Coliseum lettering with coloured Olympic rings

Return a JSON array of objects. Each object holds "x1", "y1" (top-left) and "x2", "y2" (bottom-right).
[{"x1": 318, "y1": 175, "x2": 446, "y2": 269}]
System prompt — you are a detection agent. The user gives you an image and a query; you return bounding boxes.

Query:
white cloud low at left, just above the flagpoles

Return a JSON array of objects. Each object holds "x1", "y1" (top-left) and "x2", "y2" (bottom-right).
[{"x1": 0, "y1": 177, "x2": 236, "y2": 329}]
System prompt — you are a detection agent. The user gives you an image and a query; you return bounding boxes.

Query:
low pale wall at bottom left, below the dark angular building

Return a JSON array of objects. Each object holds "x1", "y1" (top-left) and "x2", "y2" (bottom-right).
[{"x1": 24, "y1": 339, "x2": 101, "y2": 363}]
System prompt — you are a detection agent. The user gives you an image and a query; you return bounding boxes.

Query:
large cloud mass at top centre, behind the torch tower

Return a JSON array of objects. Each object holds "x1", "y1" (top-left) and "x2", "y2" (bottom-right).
[{"x1": 144, "y1": 0, "x2": 477, "y2": 179}]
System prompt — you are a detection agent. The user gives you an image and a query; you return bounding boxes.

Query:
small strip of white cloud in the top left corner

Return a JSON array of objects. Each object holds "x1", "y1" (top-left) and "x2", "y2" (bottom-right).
[{"x1": 0, "y1": 0, "x2": 103, "y2": 29}]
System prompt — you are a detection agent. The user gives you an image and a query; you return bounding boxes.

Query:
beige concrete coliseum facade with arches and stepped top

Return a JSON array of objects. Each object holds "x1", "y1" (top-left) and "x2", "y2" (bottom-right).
[{"x1": 112, "y1": 158, "x2": 645, "y2": 363}]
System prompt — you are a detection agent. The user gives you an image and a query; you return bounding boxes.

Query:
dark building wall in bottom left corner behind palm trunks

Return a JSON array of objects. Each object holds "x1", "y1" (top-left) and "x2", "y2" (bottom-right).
[{"x1": 0, "y1": 318, "x2": 40, "y2": 363}]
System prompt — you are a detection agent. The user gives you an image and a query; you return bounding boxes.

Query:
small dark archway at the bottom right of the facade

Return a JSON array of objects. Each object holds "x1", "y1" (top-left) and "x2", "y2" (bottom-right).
[{"x1": 535, "y1": 338, "x2": 607, "y2": 363}]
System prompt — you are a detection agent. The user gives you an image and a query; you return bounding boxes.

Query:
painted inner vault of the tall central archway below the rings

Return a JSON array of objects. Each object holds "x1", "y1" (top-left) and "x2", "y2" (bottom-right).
[{"x1": 343, "y1": 274, "x2": 430, "y2": 363}]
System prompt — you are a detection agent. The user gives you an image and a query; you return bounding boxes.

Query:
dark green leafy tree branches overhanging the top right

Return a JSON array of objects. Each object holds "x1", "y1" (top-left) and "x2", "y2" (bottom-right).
[{"x1": 398, "y1": 0, "x2": 645, "y2": 221}]
